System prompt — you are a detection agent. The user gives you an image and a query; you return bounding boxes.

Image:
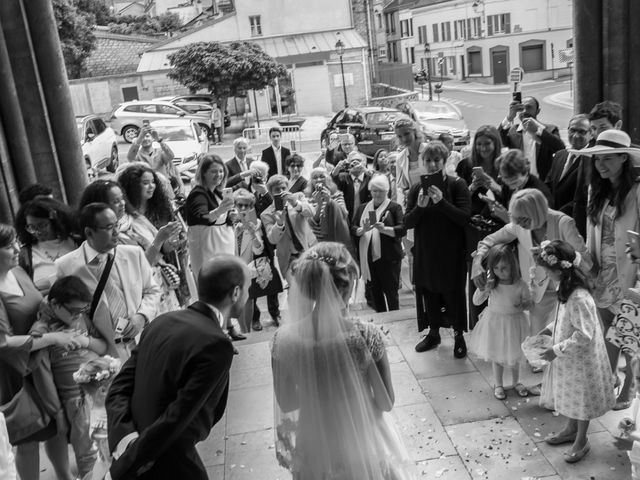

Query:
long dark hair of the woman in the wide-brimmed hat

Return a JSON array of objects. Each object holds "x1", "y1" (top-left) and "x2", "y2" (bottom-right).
[{"x1": 587, "y1": 153, "x2": 636, "y2": 225}]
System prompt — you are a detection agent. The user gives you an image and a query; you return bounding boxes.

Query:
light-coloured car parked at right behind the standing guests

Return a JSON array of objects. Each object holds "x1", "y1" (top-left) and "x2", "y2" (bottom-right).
[{"x1": 408, "y1": 100, "x2": 469, "y2": 150}]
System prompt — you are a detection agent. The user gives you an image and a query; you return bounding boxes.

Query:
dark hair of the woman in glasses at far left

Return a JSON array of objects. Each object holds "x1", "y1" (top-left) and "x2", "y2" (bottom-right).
[{"x1": 15, "y1": 196, "x2": 79, "y2": 245}]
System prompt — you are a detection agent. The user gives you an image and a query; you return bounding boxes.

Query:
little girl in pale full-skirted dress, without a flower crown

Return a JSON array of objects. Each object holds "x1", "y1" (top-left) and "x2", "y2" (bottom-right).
[{"x1": 469, "y1": 244, "x2": 532, "y2": 400}]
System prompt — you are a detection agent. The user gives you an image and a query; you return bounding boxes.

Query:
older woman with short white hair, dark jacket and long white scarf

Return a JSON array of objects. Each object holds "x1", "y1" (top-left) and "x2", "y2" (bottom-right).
[{"x1": 351, "y1": 174, "x2": 406, "y2": 312}]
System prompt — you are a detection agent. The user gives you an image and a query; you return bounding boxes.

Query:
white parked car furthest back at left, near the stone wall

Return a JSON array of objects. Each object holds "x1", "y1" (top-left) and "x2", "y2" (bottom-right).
[{"x1": 109, "y1": 100, "x2": 211, "y2": 143}]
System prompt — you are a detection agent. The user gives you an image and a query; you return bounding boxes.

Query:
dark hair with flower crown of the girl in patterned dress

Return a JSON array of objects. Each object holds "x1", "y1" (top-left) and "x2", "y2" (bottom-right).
[{"x1": 535, "y1": 240, "x2": 591, "y2": 303}]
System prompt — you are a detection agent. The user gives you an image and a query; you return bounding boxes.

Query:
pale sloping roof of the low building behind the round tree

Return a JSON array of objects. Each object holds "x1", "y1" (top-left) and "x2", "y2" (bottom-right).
[{"x1": 138, "y1": 29, "x2": 367, "y2": 72}]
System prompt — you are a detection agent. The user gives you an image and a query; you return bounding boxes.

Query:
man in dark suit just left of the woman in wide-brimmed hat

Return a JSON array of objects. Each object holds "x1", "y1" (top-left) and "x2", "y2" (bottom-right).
[{"x1": 545, "y1": 114, "x2": 591, "y2": 216}]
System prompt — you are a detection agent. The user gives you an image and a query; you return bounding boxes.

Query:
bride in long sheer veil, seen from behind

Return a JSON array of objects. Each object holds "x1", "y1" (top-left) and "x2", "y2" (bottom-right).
[{"x1": 271, "y1": 242, "x2": 416, "y2": 480}]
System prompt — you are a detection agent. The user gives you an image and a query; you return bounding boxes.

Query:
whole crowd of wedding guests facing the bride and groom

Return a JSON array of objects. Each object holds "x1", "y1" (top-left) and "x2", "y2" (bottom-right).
[{"x1": 0, "y1": 97, "x2": 640, "y2": 480}]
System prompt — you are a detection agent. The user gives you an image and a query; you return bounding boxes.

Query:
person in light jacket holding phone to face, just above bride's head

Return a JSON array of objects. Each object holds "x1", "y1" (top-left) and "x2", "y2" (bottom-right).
[{"x1": 260, "y1": 175, "x2": 317, "y2": 278}]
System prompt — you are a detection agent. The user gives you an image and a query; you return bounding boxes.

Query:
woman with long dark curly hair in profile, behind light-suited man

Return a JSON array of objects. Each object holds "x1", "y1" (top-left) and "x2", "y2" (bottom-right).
[{"x1": 118, "y1": 164, "x2": 188, "y2": 314}]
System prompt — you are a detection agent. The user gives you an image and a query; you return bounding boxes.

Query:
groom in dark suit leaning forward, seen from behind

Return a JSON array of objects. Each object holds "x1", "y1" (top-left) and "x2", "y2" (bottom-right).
[{"x1": 106, "y1": 255, "x2": 250, "y2": 480}]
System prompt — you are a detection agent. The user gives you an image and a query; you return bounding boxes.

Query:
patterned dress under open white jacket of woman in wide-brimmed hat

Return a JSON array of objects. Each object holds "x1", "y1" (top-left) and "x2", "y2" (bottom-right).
[{"x1": 593, "y1": 205, "x2": 622, "y2": 310}]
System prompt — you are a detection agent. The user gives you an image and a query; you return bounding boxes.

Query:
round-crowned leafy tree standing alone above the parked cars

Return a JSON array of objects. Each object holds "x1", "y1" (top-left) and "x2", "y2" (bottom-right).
[{"x1": 167, "y1": 42, "x2": 287, "y2": 109}]
